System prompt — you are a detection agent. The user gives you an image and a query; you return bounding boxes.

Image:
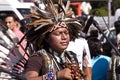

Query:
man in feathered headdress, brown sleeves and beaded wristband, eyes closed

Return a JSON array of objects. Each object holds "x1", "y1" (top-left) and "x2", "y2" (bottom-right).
[{"x1": 25, "y1": 0, "x2": 90, "y2": 80}]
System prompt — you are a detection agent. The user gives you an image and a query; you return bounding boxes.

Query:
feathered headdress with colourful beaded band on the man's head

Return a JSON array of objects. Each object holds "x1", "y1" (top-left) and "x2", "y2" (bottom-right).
[{"x1": 25, "y1": 0, "x2": 82, "y2": 49}]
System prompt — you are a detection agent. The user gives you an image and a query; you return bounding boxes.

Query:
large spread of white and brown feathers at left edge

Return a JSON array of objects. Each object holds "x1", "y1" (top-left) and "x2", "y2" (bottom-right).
[{"x1": 0, "y1": 19, "x2": 23, "y2": 80}]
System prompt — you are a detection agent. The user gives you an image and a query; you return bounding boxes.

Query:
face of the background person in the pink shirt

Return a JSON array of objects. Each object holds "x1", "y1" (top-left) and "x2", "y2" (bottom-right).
[{"x1": 5, "y1": 17, "x2": 16, "y2": 30}]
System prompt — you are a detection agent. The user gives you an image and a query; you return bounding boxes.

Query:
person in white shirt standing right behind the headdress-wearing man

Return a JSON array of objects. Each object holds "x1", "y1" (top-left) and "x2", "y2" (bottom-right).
[{"x1": 67, "y1": 32, "x2": 92, "y2": 80}]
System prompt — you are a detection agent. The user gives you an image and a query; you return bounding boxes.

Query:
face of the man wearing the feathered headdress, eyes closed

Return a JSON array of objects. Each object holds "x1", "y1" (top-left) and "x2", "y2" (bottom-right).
[{"x1": 47, "y1": 28, "x2": 70, "y2": 53}]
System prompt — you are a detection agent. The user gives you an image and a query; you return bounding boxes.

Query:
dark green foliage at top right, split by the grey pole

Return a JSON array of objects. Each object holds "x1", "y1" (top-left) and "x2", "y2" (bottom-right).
[{"x1": 91, "y1": 0, "x2": 120, "y2": 16}]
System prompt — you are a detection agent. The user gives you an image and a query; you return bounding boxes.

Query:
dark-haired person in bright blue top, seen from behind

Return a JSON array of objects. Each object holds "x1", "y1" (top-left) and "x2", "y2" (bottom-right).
[{"x1": 88, "y1": 37, "x2": 111, "y2": 80}]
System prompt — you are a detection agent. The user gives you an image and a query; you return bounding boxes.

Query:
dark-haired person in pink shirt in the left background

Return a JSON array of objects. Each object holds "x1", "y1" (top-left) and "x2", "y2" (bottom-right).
[{"x1": 5, "y1": 14, "x2": 28, "y2": 59}]
